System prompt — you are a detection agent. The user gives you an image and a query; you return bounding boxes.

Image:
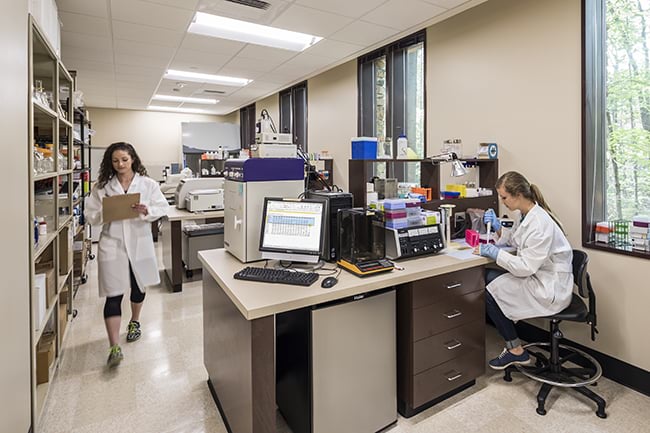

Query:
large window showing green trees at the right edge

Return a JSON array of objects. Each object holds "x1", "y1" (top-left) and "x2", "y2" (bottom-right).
[{"x1": 582, "y1": 0, "x2": 650, "y2": 258}]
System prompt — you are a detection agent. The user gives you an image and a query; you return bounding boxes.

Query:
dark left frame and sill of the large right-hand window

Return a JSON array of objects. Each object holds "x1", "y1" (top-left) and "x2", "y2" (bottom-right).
[{"x1": 581, "y1": 0, "x2": 650, "y2": 259}]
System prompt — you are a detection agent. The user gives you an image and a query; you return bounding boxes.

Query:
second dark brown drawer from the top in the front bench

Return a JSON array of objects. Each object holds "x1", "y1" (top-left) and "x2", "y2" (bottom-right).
[{"x1": 413, "y1": 290, "x2": 478, "y2": 341}]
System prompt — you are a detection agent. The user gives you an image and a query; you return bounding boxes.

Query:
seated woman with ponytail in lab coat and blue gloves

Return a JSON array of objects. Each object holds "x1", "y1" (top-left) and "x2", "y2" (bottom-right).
[{"x1": 479, "y1": 171, "x2": 573, "y2": 370}]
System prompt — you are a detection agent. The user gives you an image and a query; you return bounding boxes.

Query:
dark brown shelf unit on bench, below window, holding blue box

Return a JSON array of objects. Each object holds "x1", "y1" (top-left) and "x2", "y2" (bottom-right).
[{"x1": 348, "y1": 159, "x2": 499, "y2": 213}]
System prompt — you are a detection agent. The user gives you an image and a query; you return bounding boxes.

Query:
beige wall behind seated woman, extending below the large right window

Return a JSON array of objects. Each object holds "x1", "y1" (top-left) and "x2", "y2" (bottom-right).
[{"x1": 427, "y1": 0, "x2": 650, "y2": 370}]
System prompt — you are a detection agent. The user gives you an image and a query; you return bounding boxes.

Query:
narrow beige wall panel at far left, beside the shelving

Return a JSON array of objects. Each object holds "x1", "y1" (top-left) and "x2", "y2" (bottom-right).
[{"x1": 0, "y1": 0, "x2": 32, "y2": 432}]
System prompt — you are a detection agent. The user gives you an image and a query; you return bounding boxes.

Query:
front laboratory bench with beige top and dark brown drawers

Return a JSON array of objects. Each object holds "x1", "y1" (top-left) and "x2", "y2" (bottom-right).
[{"x1": 198, "y1": 249, "x2": 490, "y2": 433}]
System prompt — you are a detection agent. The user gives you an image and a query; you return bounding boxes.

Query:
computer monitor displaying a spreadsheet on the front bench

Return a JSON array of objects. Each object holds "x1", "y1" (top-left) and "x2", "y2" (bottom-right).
[{"x1": 260, "y1": 197, "x2": 326, "y2": 263}]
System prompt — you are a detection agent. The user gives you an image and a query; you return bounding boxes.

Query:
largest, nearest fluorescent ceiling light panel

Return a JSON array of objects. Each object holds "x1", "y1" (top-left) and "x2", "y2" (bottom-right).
[{"x1": 187, "y1": 12, "x2": 323, "y2": 51}]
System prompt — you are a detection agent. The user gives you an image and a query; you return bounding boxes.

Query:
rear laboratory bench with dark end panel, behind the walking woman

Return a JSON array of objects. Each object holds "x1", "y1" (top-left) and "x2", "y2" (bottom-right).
[{"x1": 161, "y1": 207, "x2": 224, "y2": 292}]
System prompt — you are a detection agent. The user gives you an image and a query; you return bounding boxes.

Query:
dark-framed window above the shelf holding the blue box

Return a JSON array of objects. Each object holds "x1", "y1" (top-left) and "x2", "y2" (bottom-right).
[{"x1": 358, "y1": 31, "x2": 426, "y2": 183}]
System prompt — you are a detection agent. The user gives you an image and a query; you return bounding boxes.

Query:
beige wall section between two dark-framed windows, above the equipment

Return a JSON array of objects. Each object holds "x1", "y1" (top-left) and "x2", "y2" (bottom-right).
[{"x1": 307, "y1": 60, "x2": 357, "y2": 190}]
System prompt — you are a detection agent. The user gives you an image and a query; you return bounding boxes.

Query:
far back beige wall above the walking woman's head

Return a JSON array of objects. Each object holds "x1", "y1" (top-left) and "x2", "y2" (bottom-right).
[{"x1": 89, "y1": 108, "x2": 230, "y2": 167}]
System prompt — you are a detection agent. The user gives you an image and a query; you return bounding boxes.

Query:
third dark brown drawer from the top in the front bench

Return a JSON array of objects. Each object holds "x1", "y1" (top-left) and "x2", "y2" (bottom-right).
[{"x1": 413, "y1": 321, "x2": 485, "y2": 374}]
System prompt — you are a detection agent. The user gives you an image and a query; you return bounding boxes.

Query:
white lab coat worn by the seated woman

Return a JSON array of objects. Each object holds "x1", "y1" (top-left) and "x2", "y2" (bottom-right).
[{"x1": 487, "y1": 205, "x2": 573, "y2": 321}]
